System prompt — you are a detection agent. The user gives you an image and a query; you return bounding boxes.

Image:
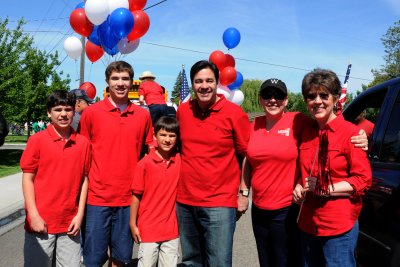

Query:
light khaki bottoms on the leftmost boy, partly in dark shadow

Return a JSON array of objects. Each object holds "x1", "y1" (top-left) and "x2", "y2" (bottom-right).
[{"x1": 24, "y1": 232, "x2": 81, "y2": 267}]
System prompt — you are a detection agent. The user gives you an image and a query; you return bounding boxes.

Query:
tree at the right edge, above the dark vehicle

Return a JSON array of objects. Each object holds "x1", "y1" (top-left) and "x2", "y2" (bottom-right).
[{"x1": 368, "y1": 20, "x2": 400, "y2": 88}]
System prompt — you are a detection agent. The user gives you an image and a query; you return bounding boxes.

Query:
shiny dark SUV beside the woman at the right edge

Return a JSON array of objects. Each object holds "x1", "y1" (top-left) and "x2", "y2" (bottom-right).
[{"x1": 343, "y1": 78, "x2": 400, "y2": 267}]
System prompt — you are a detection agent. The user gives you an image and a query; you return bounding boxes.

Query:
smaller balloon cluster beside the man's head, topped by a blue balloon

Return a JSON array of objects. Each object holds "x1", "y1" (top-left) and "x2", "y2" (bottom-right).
[{"x1": 209, "y1": 28, "x2": 244, "y2": 105}]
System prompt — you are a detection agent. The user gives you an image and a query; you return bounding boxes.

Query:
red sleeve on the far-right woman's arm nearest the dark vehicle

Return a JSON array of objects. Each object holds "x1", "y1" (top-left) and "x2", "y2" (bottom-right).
[{"x1": 346, "y1": 133, "x2": 372, "y2": 197}]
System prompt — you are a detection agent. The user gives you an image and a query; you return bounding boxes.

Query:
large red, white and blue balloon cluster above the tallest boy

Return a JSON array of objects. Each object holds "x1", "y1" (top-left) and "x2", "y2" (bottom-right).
[{"x1": 64, "y1": 0, "x2": 150, "y2": 62}]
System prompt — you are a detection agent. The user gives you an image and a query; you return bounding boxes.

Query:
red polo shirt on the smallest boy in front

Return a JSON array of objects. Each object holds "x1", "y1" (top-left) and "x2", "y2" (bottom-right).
[{"x1": 132, "y1": 150, "x2": 181, "y2": 242}]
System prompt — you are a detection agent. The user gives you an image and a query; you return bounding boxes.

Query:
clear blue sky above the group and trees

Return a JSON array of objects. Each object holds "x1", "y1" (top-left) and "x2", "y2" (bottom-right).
[{"x1": 0, "y1": 0, "x2": 400, "y2": 98}]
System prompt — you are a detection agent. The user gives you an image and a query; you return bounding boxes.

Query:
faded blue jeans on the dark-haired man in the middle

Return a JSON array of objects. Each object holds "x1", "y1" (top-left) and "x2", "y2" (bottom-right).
[{"x1": 176, "y1": 203, "x2": 236, "y2": 267}]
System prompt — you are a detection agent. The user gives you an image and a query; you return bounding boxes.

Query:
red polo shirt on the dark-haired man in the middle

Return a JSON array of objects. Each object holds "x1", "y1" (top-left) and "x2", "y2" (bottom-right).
[{"x1": 177, "y1": 95, "x2": 250, "y2": 207}]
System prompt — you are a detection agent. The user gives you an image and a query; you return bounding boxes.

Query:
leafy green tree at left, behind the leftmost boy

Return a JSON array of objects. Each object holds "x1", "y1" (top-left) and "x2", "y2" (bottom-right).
[{"x1": 0, "y1": 19, "x2": 70, "y2": 134}]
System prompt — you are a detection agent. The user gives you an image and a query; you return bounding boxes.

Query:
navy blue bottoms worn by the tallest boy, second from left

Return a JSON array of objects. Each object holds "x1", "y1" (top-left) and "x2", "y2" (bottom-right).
[{"x1": 83, "y1": 205, "x2": 133, "y2": 267}]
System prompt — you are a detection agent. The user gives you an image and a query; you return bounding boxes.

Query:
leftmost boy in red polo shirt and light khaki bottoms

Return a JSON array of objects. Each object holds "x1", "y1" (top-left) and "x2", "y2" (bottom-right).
[{"x1": 21, "y1": 90, "x2": 90, "y2": 266}]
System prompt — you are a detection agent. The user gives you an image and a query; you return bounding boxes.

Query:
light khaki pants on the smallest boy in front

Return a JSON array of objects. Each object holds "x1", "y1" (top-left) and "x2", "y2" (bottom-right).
[{"x1": 138, "y1": 238, "x2": 179, "y2": 267}]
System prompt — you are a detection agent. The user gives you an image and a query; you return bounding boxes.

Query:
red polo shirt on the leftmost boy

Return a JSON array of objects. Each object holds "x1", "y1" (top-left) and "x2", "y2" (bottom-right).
[{"x1": 20, "y1": 126, "x2": 90, "y2": 234}]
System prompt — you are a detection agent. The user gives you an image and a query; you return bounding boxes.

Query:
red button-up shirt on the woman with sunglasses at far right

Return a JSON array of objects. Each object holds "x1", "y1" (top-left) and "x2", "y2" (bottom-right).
[{"x1": 299, "y1": 115, "x2": 372, "y2": 236}]
